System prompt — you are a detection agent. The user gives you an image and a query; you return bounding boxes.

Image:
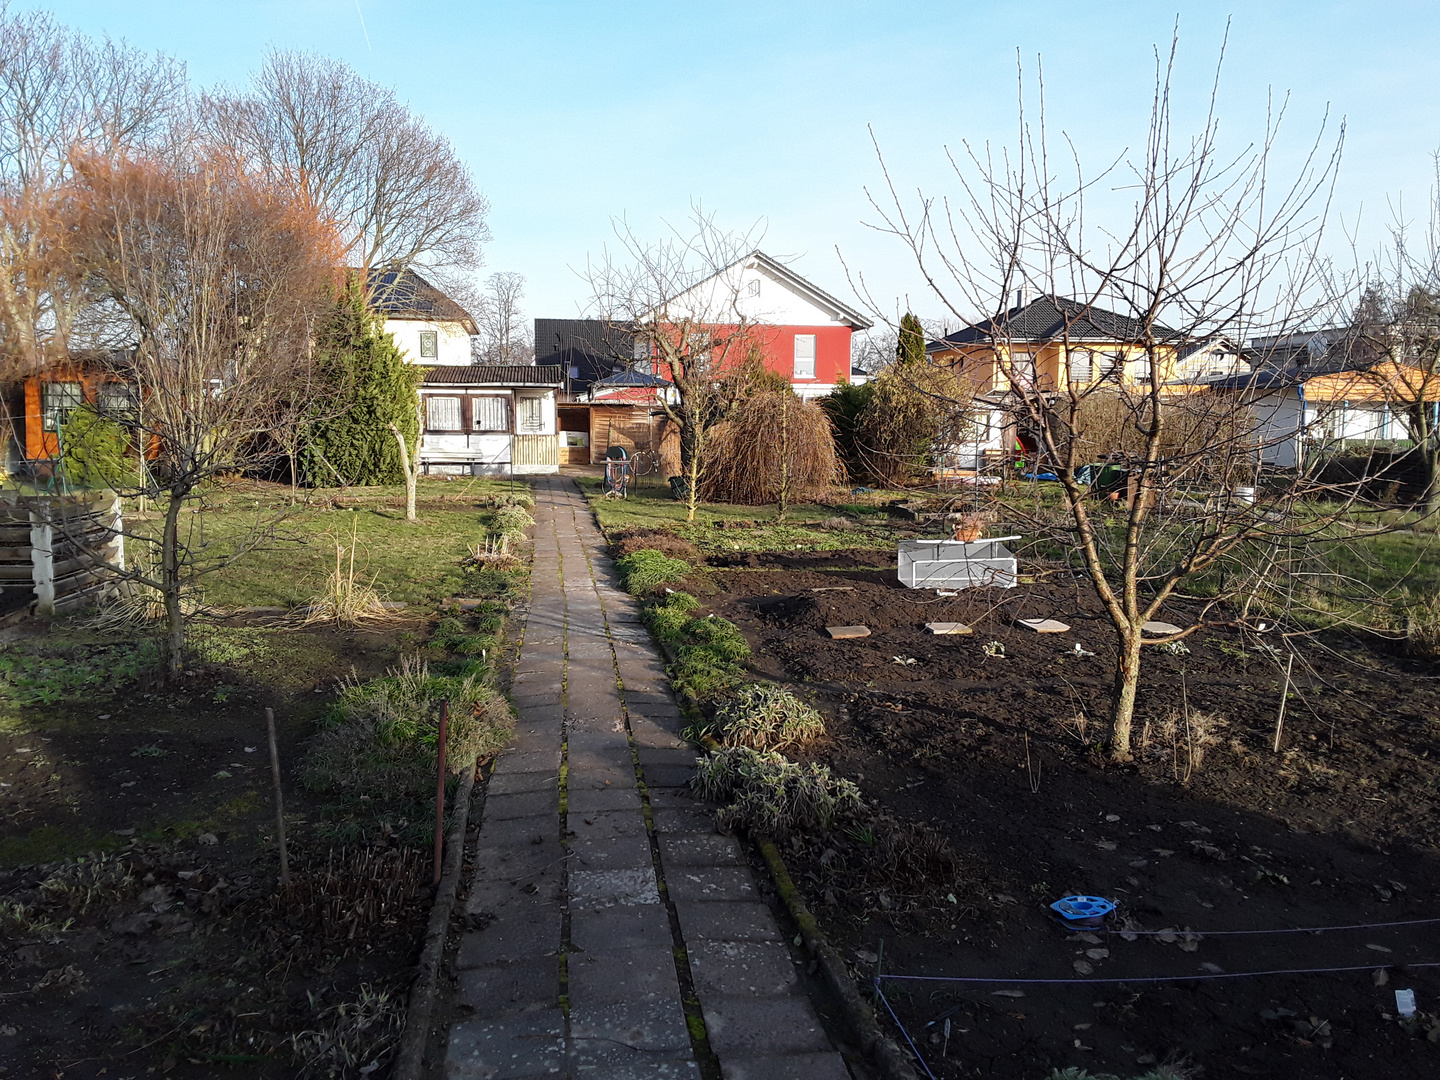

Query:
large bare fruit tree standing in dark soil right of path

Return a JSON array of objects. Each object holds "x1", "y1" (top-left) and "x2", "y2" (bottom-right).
[{"x1": 873, "y1": 40, "x2": 1370, "y2": 760}]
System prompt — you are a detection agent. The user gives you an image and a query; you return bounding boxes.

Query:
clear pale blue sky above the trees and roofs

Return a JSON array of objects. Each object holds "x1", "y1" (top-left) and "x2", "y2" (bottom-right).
[{"x1": 14, "y1": 0, "x2": 1440, "y2": 329}]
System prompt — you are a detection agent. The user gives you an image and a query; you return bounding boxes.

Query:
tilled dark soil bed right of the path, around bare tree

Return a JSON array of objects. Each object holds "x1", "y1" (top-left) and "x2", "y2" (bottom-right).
[{"x1": 696, "y1": 552, "x2": 1440, "y2": 1079}]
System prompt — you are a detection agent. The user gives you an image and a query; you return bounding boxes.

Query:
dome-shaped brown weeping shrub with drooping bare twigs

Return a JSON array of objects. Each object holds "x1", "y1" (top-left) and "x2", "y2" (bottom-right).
[{"x1": 700, "y1": 389, "x2": 845, "y2": 507}]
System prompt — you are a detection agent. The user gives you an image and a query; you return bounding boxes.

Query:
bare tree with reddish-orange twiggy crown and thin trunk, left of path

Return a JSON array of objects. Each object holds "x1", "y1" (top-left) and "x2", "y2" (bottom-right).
[{"x1": 69, "y1": 157, "x2": 338, "y2": 677}]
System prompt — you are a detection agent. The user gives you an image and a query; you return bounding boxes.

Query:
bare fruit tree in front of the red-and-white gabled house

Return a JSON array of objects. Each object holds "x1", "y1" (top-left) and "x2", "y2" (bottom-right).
[{"x1": 586, "y1": 206, "x2": 759, "y2": 521}]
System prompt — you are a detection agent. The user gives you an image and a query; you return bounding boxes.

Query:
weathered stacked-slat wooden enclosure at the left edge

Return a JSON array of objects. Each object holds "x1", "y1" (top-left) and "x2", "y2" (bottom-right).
[{"x1": 0, "y1": 492, "x2": 125, "y2": 615}]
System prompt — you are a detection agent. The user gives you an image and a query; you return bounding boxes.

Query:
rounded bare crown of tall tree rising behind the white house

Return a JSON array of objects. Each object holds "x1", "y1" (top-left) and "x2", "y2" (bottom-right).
[{"x1": 204, "y1": 50, "x2": 490, "y2": 292}]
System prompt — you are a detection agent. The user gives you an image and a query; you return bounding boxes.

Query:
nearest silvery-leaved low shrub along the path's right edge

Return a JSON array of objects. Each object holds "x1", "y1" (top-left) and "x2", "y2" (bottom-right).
[{"x1": 691, "y1": 746, "x2": 863, "y2": 837}]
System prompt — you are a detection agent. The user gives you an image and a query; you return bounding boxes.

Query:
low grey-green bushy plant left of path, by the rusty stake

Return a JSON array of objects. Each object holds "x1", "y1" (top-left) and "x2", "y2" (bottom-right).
[{"x1": 300, "y1": 657, "x2": 514, "y2": 798}]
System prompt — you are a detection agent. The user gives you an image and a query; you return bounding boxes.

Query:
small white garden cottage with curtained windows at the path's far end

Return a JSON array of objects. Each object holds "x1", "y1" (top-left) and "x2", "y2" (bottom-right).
[{"x1": 420, "y1": 364, "x2": 564, "y2": 477}]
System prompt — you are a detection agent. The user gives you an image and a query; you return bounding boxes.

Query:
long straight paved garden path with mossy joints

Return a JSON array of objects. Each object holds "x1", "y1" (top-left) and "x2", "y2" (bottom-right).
[{"x1": 446, "y1": 478, "x2": 850, "y2": 1080}]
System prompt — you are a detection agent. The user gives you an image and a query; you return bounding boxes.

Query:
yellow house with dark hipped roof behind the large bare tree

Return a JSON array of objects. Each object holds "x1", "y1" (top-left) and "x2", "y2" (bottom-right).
[{"x1": 926, "y1": 297, "x2": 1185, "y2": 399}]
